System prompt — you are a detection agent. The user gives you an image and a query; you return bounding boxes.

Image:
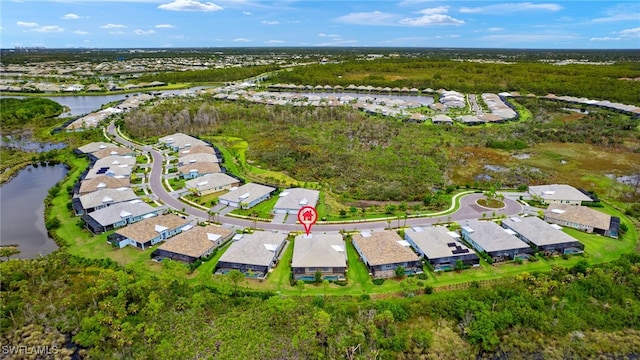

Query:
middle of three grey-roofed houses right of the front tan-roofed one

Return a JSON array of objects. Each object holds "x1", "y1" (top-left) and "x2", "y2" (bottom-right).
[{"x1": 461, "y1": 220, "x2": 533, "y2": 261}]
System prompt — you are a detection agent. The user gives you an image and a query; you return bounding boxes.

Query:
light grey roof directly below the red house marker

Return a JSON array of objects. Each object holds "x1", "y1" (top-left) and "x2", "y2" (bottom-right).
[{"x1": 291, "y1": 234, "x2": 347, "y2": 268}]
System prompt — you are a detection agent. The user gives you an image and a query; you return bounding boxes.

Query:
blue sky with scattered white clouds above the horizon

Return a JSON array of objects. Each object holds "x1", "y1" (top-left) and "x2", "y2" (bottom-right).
[{"x1": 0, "y1": 0, "x2": 640, "y2": 49}]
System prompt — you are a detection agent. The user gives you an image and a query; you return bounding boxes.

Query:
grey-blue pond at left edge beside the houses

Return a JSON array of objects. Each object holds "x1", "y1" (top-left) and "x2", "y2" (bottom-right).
[{"x1": 0, "y1": 165, "x2": 68, "y2": 259}]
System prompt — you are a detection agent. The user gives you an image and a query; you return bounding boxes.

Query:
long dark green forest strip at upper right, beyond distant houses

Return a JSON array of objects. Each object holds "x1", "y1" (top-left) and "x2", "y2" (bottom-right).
[{"x1": 270, "y1": 59, "x2": 640, "y2": 104}]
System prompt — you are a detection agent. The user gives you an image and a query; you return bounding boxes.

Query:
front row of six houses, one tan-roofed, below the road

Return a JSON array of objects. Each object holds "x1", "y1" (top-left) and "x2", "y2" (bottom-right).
[{"x1": 216, "y1": 211, "x2": 584, "y2": 281}]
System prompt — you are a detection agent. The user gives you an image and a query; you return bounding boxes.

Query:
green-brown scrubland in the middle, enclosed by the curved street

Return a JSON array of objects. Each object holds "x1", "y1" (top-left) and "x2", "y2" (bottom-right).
[{"x1": 124, "y1": 97, "x2": 639, "y2": 201}]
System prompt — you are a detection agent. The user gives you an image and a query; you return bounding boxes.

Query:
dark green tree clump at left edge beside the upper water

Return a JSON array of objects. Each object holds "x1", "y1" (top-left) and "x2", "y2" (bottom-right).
[{"x1": 0, "y1": 98, "x2": 64, "y2": 133}]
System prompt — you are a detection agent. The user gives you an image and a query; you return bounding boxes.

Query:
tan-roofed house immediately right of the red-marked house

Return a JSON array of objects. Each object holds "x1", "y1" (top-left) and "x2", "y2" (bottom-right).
[{"x1": 353, "y1": 230, "x2": 422, "y2": 278}]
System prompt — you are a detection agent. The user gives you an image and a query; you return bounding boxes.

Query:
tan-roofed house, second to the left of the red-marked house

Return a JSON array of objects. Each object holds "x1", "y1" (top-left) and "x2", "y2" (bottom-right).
[{"x1": 151, "y1": 225, "x2": 235, "y2": 264}]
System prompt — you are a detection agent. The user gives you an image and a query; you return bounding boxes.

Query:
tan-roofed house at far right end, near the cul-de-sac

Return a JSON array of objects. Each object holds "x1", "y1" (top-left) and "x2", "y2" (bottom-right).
[{"x1": 544, "y1": 204, "x2": 620, "y2": 238}]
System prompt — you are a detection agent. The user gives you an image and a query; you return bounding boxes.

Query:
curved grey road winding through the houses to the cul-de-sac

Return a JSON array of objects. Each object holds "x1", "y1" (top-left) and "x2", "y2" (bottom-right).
[{"x1": 107, "y1": 123, "x2": 523, "y2": 232}]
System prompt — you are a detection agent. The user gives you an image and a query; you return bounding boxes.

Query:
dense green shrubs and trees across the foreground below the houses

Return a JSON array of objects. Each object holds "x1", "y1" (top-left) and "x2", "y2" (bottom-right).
[{"x1": 0, "y1": 251, "x2": 640, "y2": 359}]
